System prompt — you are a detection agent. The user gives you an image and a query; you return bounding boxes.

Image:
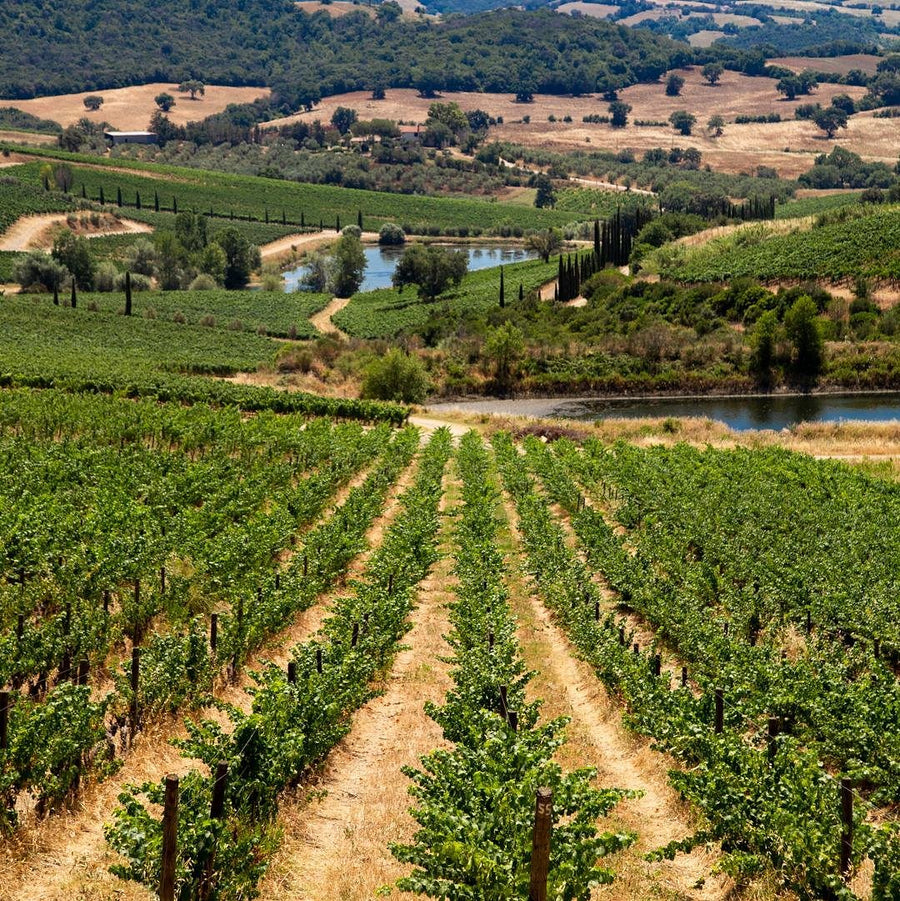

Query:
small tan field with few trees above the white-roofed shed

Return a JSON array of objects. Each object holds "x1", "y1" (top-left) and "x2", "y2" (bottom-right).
[{"x1": 3, "y1": 83, "x2": 269, "y2": 132}]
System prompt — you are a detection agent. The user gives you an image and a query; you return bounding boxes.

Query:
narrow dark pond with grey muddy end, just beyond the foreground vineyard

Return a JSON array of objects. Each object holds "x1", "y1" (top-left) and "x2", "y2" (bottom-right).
[{"x1": 434, "y1": 392, "x2": 900, "y2": 432}]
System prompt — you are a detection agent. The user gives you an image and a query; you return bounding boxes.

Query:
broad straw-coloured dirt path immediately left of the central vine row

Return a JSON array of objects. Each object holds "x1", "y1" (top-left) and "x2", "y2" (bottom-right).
[{"x1": 260, "y1": 464, "x2": 456, "y2": 901}]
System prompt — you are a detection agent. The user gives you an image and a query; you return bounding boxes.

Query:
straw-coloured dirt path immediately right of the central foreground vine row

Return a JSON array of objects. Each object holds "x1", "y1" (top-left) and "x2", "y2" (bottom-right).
[{"x1": 504, "y1": 492, "x2": 730, "y2": 901}]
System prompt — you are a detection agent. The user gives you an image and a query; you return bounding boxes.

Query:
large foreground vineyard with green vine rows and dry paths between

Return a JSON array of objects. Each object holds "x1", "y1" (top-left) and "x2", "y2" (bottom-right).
[{"x1": 0, "y1": 389, "x2": 900, "y2": 901}]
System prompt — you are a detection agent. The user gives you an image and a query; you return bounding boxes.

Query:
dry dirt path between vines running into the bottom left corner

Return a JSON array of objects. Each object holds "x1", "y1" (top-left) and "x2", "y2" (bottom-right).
[{"x1": 0, "y1": 465, "x2": 398, "y2": 901}]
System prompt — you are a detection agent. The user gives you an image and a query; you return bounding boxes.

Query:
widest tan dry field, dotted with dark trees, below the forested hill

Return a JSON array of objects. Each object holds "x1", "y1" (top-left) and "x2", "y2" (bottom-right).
[{"x1": 271, "y1": 68, "x2": 888, "y2": 177}]
